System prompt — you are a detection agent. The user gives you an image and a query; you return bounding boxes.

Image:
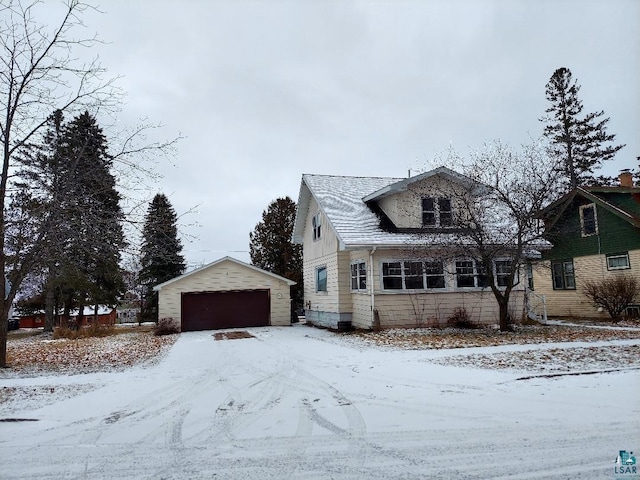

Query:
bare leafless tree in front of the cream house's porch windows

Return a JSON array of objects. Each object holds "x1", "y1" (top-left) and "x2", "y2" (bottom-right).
[{"x1": 427, "y1": 141, "x2": 559, "y2": 331}]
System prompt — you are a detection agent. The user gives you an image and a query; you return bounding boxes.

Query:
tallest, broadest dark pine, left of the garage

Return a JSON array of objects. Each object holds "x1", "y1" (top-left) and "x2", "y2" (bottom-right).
[{"x1": 59, "y1": 112, "x2": 126, "y2": 322}]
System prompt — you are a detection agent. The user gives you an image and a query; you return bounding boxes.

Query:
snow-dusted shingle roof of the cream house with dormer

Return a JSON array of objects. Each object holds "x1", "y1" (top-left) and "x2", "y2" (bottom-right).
[{"x1": 293, "y1": 167, "x2": 544, "y2": 250}]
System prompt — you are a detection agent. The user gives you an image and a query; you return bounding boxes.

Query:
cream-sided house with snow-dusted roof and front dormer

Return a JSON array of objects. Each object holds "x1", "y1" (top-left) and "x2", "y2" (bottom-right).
[{"x1": 293, "y1": 167, "x2": 526, "y2": 328}]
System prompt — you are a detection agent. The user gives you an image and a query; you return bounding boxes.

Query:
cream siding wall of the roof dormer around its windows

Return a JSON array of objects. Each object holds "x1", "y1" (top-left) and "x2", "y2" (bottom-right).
[{"x1": 378, "y1": 176, "x2": 467, "y2": 228}]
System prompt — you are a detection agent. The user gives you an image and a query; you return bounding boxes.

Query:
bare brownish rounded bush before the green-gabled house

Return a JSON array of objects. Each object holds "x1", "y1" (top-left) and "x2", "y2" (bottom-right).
[{"x1": 582, "y1": 275, "x2": 640, "y2": 321}]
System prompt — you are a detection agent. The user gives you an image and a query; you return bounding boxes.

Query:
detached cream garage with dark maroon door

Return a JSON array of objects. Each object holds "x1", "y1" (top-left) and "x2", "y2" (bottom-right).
[{"x1": 154, "y1": 257, "x2": 295, "y2": 332}]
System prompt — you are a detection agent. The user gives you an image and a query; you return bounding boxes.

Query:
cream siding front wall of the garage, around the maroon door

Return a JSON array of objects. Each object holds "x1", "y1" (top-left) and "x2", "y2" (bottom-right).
[{"x1": 158, "y1": 260, "x2": 291, "y2": 325}]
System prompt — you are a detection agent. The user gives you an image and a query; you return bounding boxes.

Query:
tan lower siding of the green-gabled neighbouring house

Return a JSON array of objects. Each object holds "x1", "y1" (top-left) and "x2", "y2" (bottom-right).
[{"x1": 533, "y1": 250, "x2": 640, "y2": 319}]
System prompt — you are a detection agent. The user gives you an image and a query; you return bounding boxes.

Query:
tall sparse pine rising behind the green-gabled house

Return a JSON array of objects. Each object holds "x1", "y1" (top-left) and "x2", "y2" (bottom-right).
[{"x1": 540, "y1": 68, "x2": 624, "y2": 188}]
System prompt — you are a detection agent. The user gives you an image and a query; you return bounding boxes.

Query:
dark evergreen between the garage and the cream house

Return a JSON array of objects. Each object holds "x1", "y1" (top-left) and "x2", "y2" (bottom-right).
[{"x1": 249, "y1": 197, "x2": 304, "y2": 306}]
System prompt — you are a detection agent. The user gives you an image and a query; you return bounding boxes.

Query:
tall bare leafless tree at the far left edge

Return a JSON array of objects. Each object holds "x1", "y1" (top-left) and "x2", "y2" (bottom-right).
[{"x1": 0, "y1": 0, "x2": 177, "y2": 367}]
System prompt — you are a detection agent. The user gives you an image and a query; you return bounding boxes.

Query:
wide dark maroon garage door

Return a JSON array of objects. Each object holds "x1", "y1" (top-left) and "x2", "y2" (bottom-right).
[{"x1": 182, "y1": 290, "x2": 271, "y2": 332}]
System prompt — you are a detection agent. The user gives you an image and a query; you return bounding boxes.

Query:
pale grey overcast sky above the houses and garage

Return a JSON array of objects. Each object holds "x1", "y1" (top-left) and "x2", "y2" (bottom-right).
[{"x1": 48, "y1": 0, "x2": 640, "y2": 267}]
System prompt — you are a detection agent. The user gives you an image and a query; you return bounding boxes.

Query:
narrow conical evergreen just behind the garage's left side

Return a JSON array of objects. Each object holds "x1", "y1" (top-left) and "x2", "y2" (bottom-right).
[{"x1": 140, "y1": 193, "x2": 185, "y2": 322}]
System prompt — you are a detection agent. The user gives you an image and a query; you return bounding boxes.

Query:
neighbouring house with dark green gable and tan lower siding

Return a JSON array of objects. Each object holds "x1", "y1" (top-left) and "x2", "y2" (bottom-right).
[{"x1": 533, "y1": 172, "x2": 640, "y2": 319}]
